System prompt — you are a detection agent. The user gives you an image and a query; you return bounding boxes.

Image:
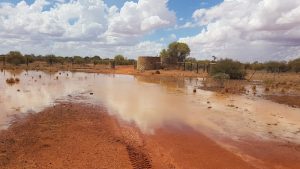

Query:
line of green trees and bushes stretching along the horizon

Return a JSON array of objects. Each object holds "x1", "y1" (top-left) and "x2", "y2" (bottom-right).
[{"x1": 0, "y1": 42, "x2": 300, "y2": 79}]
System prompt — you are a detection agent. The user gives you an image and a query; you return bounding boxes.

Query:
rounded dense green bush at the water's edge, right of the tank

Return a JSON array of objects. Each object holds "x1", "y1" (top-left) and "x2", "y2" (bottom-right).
[{"x1": 210, "y1": 59, "x2": 246, "y2": 79}]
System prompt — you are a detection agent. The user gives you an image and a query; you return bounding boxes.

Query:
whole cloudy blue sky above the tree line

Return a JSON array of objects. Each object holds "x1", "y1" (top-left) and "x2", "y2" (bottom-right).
[{"x1": 0, "y1": 0, "x2": 300, "y2": 62}]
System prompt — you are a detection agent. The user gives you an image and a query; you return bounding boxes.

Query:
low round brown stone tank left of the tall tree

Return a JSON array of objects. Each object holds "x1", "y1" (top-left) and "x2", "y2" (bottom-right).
[{"x1": 137, "y1": 56, "x2": 161, "y2": 71}]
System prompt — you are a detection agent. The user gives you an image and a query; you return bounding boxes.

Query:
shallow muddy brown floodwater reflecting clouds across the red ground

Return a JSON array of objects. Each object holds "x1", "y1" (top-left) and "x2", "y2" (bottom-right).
[{"x1": 0, "y1": 71, "x2": 300, "y2": 143}]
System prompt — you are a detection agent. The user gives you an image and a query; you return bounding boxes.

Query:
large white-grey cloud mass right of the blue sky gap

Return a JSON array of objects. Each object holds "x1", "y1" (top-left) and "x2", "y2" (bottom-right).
[{"x1": 180, "y1": 0, "x2": 300, "y2": 61}]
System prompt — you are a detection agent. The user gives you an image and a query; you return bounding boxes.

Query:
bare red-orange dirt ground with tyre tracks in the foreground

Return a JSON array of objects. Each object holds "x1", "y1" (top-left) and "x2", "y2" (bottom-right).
[{"x1": 0, "y1": 103, "x2": 262, "y2": 169}]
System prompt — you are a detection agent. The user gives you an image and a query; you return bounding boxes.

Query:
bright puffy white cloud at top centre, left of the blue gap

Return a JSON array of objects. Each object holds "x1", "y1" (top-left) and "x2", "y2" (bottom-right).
[{"x1": 108, "y1": 0, "x2": 176, "y2": 36}]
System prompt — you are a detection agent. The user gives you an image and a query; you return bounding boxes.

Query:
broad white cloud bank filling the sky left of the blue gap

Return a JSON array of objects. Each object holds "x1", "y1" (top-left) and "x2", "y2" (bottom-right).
[{"x1": 0, "y1": 0, "x2": 176, "y2": 55}]
